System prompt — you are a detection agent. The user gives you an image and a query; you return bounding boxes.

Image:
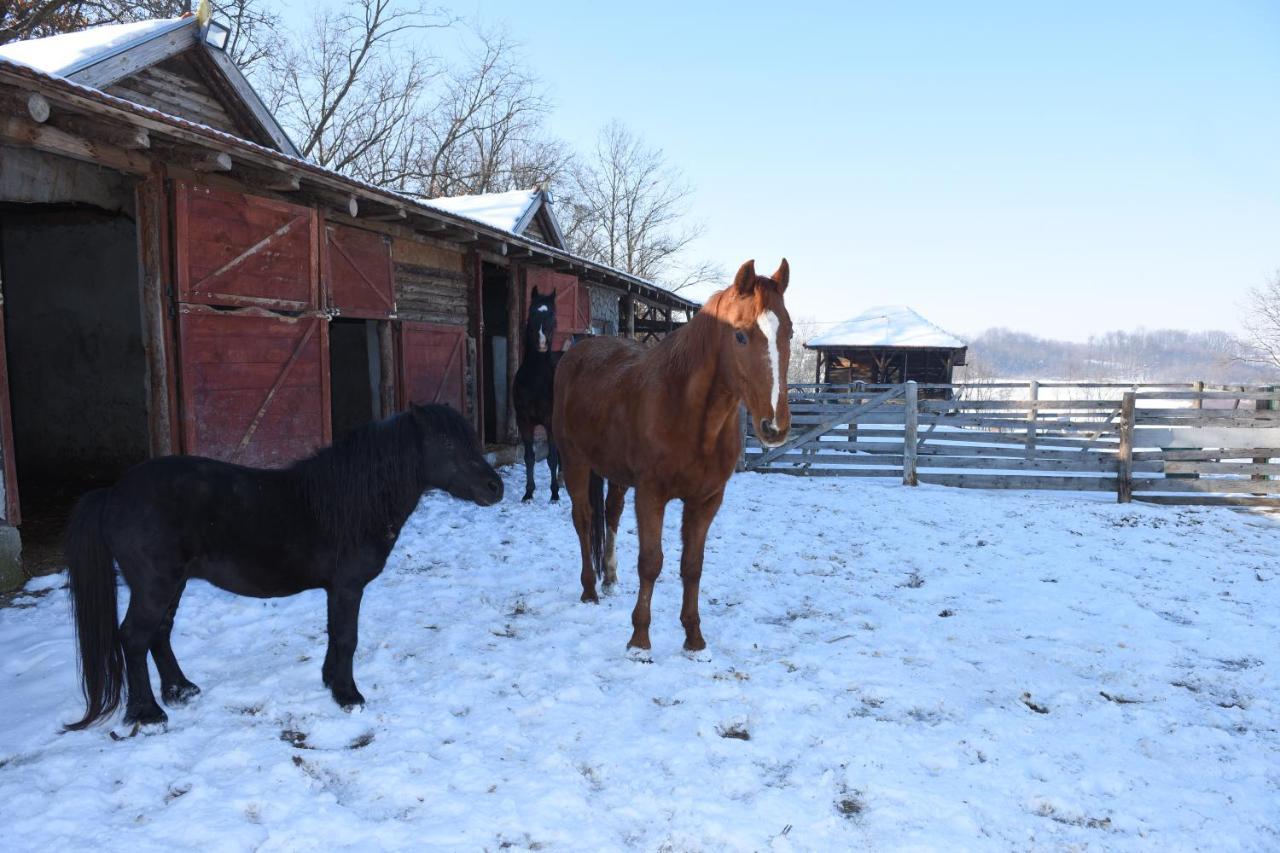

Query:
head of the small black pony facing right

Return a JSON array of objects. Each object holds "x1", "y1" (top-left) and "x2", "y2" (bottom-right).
[{"x1": 412, "y1": 405, "x2": 503, "y2": 506}]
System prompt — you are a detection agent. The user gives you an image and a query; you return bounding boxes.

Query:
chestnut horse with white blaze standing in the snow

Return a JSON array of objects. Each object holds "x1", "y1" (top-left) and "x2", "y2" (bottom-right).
[{"x1": 553, "y1": 259, "x2": 791, "y2": 651}]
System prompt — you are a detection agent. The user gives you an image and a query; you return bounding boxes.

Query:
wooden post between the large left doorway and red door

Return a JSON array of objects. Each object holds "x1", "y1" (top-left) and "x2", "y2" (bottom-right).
[{"x1": 136, "y1": 167, "x2": 179, "y2": 456}]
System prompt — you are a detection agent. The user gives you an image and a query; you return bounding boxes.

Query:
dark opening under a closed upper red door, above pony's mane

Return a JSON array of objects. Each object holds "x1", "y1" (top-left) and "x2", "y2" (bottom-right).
[{"x1": 329, "y1": 318, "x2": 383, "y2": 442}]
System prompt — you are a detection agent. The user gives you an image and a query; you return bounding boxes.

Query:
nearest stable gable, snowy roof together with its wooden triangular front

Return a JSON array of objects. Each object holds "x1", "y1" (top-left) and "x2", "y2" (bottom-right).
[{"x1": 0, "y1": 14, "x2": 300, "y2": 156}]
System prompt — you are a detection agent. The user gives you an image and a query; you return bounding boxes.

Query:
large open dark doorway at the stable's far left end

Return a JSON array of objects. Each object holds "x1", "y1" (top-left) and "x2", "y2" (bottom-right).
[{"x1": 0, "y1": 205, "x2": 150, "y2": 575}]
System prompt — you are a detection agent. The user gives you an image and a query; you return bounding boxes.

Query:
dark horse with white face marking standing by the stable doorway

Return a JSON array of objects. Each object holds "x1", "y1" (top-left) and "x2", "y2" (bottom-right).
[{"x1": 511, "y1": 287, "x2": 561, "y2": 503}]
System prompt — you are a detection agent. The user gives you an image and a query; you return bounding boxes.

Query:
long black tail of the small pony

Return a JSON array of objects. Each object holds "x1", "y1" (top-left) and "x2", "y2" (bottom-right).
[{"x1": 67, "y1": 489, "x2": 124, "y2": 729}]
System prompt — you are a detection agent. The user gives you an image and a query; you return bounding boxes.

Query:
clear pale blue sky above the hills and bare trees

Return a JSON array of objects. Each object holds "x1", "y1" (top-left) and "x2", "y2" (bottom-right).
[{"x1": 285, "y1": 0, "x2": 1280, "y2": 339}]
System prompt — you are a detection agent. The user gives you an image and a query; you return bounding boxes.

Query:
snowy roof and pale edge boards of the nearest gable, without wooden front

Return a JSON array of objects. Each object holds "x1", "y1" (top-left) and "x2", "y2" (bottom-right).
[{"x1": 0, "y1": 15, "x2": 300, "y2": 156}]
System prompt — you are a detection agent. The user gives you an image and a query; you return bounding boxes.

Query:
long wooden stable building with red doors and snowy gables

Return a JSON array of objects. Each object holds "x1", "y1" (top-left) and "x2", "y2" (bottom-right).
[{"x1": 0, "y1": 17, "x2": 698, "y2": 588}]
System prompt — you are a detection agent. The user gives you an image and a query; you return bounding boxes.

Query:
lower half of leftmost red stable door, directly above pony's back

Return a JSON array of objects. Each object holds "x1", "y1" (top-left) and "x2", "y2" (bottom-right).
[{"x1": 178, "y1": 305, "x2": 330, "y2": 467}]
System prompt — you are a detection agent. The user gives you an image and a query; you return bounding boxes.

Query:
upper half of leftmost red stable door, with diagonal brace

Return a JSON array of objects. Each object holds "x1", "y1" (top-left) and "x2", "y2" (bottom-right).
[{"x1": 174, "y1": 181, "x2": 320, "y2": 311}]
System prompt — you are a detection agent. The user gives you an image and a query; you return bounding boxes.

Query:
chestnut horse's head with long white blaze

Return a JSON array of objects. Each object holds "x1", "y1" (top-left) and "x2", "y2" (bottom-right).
[{"x1": 708, "y1": 257, "x2": 791, "y2": 447}]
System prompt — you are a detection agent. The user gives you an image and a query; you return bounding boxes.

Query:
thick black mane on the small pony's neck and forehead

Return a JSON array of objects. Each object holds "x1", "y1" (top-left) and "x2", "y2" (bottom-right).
[{"x1": 289, "y1": 406, "x2": 476, "y2": 553}]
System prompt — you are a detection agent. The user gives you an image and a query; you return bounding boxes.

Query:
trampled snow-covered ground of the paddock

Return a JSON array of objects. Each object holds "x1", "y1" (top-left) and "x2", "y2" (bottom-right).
[{"x1": 0, "y1": 469, "x2": 1280, "y2": 850}]
